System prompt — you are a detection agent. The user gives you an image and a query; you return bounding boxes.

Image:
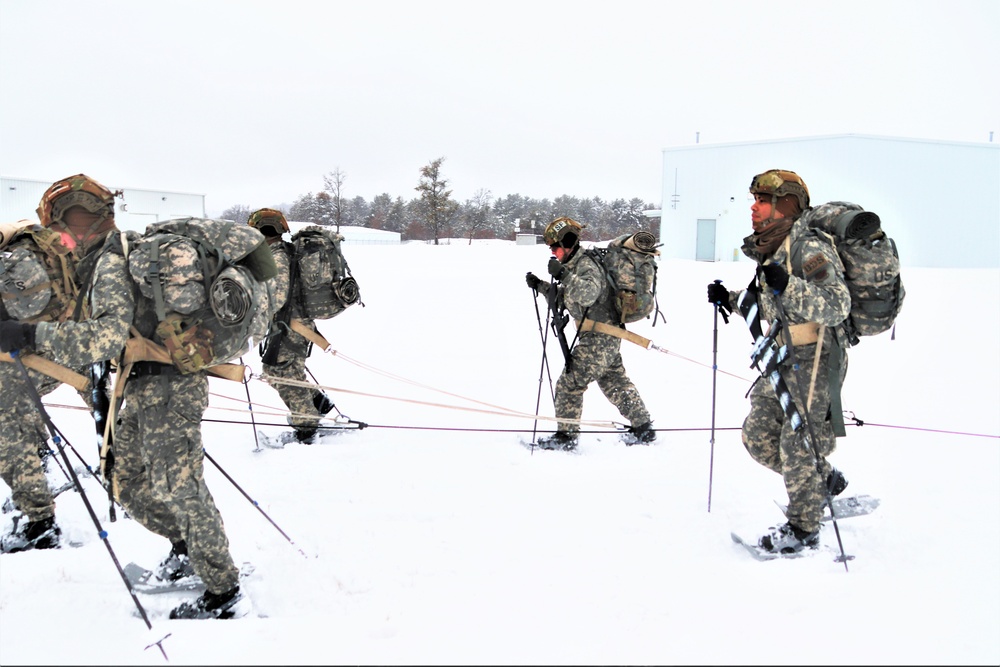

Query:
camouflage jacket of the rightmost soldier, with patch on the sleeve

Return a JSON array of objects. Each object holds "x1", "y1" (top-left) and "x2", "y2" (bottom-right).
[{"x1": 729, "y1": 217, "x2": 851, "y2": 342}]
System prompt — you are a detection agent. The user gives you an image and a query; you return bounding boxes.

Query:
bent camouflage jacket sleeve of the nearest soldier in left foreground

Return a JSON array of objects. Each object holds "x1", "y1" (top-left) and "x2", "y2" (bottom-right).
[{"x1": 35, "y1": 230, "x2": 138, "y2": 368}]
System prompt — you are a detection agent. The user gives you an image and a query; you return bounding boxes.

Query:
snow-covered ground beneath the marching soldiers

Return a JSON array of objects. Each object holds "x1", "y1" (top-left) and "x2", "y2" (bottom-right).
[{"x1": 0, "y1": 241, "x2": 1000, "y2": 665}]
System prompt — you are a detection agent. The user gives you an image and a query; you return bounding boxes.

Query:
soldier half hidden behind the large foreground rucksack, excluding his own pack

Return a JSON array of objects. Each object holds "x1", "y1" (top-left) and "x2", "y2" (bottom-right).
[{"x1": 248, "y1": 208, "x2": 334, "y2": 444}]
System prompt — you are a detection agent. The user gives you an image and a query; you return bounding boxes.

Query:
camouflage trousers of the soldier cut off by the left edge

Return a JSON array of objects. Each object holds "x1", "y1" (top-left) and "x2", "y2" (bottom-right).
[{"x1": 0, "y1": 362, "x2": 93, "y2": 521}]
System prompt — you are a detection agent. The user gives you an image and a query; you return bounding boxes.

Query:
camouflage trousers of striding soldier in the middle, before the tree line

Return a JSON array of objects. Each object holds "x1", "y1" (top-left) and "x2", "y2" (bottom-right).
[{"x1": 555, "y1": 333, "x2": 649, "y2": 433}]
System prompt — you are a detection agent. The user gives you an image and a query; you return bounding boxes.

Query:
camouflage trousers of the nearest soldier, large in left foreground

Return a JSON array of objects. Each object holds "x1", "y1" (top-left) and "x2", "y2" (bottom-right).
[{"x1": 114, "y1": 373, "x2": 239, "y2": 593}]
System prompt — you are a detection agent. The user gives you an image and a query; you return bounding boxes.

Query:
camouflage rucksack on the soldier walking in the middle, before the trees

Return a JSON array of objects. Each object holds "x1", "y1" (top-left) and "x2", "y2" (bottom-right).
[{"x1": 585, "y1": 232, "x2": 660, "y2": 325}]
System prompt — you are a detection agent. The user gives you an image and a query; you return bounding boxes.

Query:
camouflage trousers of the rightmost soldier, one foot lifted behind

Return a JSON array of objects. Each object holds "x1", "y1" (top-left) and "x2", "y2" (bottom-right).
[{"x1": 743, "y1": 332, "x2": 847, "y2": 532}]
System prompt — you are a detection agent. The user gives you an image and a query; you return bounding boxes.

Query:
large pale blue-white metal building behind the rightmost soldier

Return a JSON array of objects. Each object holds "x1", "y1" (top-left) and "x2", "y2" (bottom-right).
[{"x1": 660, "y1": 134, "x2": 1000, "y2": 268}]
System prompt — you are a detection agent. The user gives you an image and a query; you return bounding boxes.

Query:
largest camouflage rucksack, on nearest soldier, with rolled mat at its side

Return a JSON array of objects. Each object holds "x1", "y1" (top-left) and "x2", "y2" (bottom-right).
[{"x1": 128, "y1": 218, "x2": 277, "y2": 373}]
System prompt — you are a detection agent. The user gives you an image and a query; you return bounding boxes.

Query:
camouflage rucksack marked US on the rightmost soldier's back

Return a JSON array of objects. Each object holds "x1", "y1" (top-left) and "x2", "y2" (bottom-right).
[{"x1": 791, "y1": 201, "x2": 906, "y2": 345}]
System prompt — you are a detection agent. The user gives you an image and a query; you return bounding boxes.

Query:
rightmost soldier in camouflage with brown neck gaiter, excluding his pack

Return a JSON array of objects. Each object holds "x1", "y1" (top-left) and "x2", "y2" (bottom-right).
[{"x1": 708, "y1": 169, "x2": 851, "y2": 553}]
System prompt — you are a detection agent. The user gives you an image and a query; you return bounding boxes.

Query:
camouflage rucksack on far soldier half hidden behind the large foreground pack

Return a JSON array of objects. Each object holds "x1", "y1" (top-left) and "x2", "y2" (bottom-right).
[{"x1": 292, "y1": 225, "x2": 364, "y2": 320}]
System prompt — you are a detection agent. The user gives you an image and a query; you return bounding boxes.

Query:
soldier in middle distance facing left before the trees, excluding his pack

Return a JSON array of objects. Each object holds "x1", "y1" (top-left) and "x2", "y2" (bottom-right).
[{"x1": 525, "y1": 218, "x2": 656, "y2": 449}]
